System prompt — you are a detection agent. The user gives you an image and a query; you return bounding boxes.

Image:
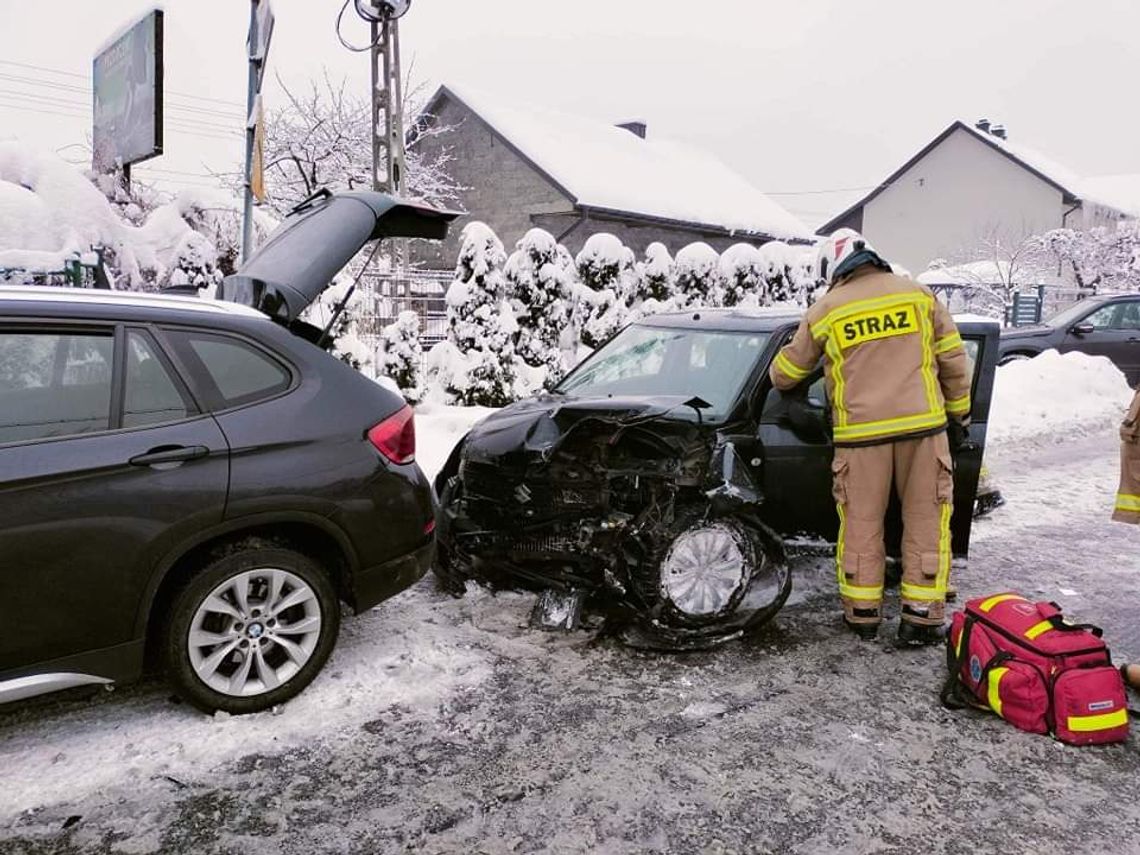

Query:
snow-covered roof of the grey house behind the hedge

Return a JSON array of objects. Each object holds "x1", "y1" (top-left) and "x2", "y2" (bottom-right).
[{"x1": 425, "y1": 84, "x2": 812, "y2": 241}]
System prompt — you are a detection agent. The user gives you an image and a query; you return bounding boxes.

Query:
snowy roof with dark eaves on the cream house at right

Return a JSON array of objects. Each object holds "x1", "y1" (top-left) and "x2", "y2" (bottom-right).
[{"x1": 816, "y1": 119, "x2": 1140, "y2": 235}]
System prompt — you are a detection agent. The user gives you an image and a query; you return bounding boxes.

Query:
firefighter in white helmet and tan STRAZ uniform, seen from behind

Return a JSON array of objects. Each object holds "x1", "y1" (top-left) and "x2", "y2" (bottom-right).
[{"x1": 771, "y1": 229, "x2": 970, "y2": 644}]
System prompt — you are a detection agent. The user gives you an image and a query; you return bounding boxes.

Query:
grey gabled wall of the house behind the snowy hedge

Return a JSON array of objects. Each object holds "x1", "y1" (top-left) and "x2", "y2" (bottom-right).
[{"x1": 412, "y1": 97, "x2": 784, "y2": 269}]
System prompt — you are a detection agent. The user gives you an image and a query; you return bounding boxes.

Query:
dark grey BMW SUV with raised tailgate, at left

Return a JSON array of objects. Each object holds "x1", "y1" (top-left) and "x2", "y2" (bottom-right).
[{"x1": 0, "y1": 194, "x2": 451, "y2": 713}]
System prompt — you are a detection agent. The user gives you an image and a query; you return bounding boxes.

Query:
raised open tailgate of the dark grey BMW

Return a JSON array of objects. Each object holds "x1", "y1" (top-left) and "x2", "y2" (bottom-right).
[{"x1": 218, "y1": 190, "x2": 458, "y2": 324}]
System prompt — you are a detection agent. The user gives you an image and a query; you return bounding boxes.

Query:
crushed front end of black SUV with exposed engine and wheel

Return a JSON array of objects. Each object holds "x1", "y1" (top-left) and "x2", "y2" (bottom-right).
[{"x1": 435, "y1": 396, "x2": 791, "y2": 649}]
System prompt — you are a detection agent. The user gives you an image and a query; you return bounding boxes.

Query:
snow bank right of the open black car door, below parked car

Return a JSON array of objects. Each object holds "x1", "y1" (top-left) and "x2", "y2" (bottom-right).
[{"x1": 986, "y1": 350, "x2": 1132, "y2": 449}]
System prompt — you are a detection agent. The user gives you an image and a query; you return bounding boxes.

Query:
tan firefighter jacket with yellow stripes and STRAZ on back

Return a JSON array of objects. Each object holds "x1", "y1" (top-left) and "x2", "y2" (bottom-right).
[{"x1": 771, "y1": 266, "x2": 971, "y2": 446}]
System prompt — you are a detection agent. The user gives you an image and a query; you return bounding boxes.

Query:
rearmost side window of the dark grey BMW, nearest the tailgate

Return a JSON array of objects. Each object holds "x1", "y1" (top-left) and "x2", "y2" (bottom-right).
[{"x1": 168, "y1": 331, "x2": 292, "y2": 408}]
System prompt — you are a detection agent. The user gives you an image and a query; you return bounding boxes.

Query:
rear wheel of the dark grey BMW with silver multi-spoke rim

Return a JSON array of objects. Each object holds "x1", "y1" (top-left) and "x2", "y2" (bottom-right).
[{"x1": 163, "y1": 547, "x2": 341, "y2": 714}]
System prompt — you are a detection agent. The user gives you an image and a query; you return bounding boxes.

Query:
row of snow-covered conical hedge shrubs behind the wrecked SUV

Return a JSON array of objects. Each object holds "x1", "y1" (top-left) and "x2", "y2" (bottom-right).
[{"x1": 426, "y1": 221, "x2": 816, "y2": 407}]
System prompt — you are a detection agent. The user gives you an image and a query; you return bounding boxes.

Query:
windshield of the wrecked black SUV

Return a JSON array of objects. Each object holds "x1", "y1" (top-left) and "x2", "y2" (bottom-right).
[{"x1": 555, "y1": 325, "x2": 768, "y2": 421}]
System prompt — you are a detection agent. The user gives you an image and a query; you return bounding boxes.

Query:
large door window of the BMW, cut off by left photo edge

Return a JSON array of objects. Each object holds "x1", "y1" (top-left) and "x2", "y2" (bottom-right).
[{"x1": 0, "y1": 331, "x2": 115, "y2": 442}]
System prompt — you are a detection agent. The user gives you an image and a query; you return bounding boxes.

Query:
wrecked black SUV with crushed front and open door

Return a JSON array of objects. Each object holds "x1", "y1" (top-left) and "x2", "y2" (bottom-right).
[{"x1": 434, "y1": 309, "x2": 999, "y2": 649}]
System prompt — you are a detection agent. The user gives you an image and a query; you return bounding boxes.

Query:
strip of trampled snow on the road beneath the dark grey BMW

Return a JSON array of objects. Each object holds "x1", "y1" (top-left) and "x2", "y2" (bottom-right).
[{"x1": 0, "y1": 585, "x2": 490, "y2": 825}]
